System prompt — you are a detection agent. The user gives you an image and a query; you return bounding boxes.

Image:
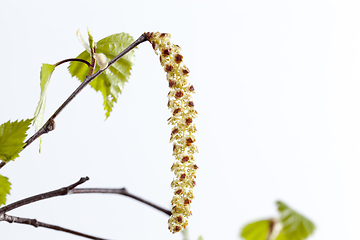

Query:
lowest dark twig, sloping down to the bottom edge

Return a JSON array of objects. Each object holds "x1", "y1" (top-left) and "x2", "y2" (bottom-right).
[{"x1": 0, "y1": 214, "x2": 106, "y2": 240}]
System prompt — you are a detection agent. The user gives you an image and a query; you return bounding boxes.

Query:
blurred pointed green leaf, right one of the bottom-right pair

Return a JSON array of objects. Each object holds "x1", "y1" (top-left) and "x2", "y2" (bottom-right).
[{"x1": 276, "y1": 201, "x2": 315, "y2": 240}]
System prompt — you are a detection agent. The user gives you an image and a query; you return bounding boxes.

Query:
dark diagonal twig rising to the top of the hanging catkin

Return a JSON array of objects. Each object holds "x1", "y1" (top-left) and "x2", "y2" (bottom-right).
[{"x1": 0, "y1": 33, "x2": 147, "y2": 169}]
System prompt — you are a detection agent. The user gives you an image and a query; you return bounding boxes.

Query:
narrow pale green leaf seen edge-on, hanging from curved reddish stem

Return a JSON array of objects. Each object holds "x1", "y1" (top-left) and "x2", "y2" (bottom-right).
[{"x1": 34, "y1": 63, "x2": 55, "y2": 152}]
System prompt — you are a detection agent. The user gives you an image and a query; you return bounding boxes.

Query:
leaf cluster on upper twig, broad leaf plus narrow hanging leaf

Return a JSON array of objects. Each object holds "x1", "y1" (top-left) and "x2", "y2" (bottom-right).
[{"x1": 34, "y1": 30, "x2": 135, "y2": 152}]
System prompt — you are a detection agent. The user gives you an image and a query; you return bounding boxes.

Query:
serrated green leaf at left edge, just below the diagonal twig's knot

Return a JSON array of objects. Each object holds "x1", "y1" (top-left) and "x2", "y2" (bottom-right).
[{"x1": 0, "y1": 119, "x2": 33, "y2": 162}]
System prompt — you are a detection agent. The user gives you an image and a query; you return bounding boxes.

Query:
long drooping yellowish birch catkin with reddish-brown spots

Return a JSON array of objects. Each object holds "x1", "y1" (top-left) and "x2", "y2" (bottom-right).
[{"x1": 147, "y1": 32, "x2": 198, "y2": 233}]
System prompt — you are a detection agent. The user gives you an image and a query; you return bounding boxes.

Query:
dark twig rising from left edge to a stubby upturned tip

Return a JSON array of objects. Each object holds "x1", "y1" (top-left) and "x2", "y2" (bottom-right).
[{"x1": 0, "y1": 177, "x2": 89, "y2": 213}]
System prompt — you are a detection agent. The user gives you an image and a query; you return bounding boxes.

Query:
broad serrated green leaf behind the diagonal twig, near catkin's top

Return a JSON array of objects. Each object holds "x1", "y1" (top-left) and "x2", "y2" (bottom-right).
[{"x1": 69, "y1": 33, "x2": 135, "y2": 118}]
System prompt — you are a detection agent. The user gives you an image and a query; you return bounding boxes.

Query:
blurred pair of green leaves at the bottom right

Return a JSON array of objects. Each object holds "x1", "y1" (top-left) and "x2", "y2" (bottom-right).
[{"x1": 240, "y1": 201, "x2": 315, "y2": 240}]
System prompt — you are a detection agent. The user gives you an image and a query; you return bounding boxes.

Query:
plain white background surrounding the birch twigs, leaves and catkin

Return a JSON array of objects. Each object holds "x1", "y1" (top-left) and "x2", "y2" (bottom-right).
[{"x1": 0, "y1": 0, "x2": 360, "y2": 240}]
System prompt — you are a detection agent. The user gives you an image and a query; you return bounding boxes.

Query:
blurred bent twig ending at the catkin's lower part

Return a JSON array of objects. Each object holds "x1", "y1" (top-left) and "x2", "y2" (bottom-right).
[{"x1": 71, "y1": 188, "x2": 171, "y2": 216}]
